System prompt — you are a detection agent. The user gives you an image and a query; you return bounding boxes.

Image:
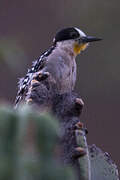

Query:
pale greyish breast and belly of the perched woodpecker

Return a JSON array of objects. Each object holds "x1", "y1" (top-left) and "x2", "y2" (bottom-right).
[{"x1": 45, "y1": 51, "x2": 76, "y2": 93}]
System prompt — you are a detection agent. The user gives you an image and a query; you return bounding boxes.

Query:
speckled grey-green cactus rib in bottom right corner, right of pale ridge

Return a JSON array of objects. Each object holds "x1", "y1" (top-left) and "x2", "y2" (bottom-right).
[{"x1": 89, "y1": 145, "x2": 119, "y2": 180}]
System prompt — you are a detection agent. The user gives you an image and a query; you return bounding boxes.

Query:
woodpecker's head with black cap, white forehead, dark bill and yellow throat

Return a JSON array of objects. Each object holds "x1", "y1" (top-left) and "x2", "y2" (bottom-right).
[{"x1": 53, "y1": 27, "x2": 101, "y2": 55}]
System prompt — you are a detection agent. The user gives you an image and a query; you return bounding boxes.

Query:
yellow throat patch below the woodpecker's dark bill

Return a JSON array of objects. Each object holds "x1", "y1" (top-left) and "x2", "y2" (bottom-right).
[{"x1": 73, "y1": 43, "x2": 88, "y2": 55}]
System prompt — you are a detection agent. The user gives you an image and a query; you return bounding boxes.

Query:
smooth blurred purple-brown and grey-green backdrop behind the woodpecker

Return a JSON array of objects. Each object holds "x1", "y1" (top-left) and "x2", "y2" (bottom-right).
[{"x1": 0, "y1": 0, "x2": 120, "y2": 169}]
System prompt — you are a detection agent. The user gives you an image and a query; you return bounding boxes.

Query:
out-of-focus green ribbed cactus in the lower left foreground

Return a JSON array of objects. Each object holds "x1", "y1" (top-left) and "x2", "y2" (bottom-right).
[{"x1": 0, "y1": 107, "x2": 75, "y2": 180}]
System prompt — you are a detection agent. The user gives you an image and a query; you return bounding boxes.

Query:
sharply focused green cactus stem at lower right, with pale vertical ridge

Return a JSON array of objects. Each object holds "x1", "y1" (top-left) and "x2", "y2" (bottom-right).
[{"x1": 76, "y1": 129, "x2": 119, "y2": 180}]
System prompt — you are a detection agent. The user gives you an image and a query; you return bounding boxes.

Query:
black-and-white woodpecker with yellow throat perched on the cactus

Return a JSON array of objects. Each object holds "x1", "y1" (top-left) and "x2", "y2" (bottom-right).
[{"x1": 15, "y1": 27, "x2": 102, "y2": 107}]
